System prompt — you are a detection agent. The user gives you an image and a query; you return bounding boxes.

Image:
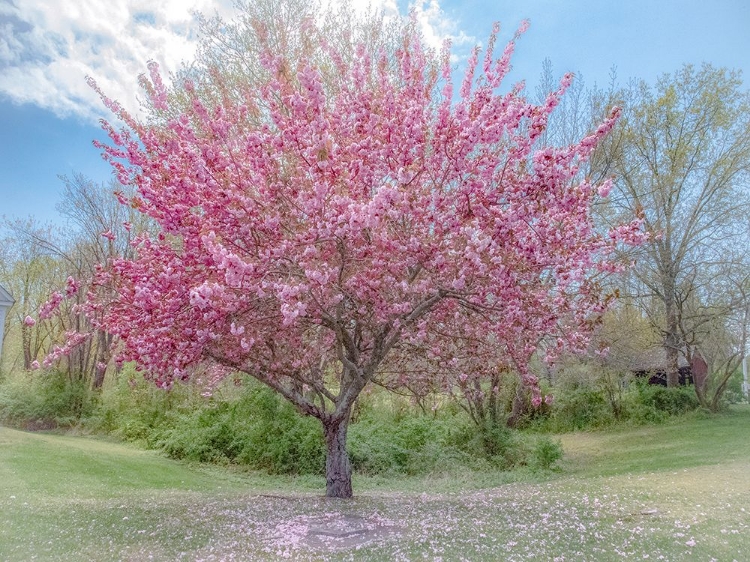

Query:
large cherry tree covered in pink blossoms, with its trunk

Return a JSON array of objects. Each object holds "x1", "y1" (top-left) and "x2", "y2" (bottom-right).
[{"x1": 75, "y1": 26, "x2": 639, "y2": 497}]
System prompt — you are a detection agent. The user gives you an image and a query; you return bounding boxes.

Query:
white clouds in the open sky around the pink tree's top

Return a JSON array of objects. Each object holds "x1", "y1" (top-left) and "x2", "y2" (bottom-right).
[{"x1": 0, "y1": 0, "x2": 469, "y2": 121}]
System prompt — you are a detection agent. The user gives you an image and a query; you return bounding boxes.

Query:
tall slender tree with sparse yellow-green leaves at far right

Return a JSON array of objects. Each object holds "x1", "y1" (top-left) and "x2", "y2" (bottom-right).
[{"x1": 596, "y1": 65, "x2": 750, "y2": 386}]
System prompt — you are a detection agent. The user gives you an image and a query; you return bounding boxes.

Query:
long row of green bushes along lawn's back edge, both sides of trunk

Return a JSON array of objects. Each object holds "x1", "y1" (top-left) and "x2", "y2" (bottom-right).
[{"x1": 0, "y1": 360, "x2": 698, "y2": 475}]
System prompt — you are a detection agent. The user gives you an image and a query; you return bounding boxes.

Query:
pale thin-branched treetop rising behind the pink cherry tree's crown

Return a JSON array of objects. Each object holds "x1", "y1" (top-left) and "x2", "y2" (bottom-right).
[{"x1": 148, "y1": 0, "x2": 400, "y2": 123}]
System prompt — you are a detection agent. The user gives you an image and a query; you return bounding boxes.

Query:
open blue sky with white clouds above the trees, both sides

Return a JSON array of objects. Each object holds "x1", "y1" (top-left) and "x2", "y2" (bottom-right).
[{"x1": 0, "y1": 0, "x2": 750, "y2": 228}]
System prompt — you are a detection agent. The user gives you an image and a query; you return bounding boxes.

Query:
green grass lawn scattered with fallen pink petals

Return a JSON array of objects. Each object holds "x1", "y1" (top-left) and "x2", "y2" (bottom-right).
[{"x1": 0, "y1": 407, "x2": 750, "y2": 562}]
